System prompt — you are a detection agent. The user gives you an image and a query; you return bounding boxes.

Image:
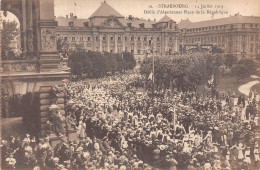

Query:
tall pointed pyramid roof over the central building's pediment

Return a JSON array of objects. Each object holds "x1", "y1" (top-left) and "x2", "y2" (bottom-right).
[{"x1": 89, "y1": 1, "x2": 124, "y2": 18}]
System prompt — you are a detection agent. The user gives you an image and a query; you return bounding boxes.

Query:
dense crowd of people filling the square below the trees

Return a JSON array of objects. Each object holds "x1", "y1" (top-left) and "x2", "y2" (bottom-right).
[{"x1": 1, "y1": 74, "x2": 259, "y2": 170}]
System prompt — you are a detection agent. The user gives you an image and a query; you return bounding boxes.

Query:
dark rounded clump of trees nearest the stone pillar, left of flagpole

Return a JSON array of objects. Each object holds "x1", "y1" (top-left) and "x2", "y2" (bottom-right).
[{"x1": 69, "y1": 50, "x2": 136, "y2": 78}]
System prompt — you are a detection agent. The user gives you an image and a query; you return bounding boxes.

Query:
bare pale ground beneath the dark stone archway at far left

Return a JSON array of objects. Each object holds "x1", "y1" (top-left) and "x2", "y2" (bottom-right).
[{"x1": 0, "y1": 117, "x2": 26, "y2": 139}]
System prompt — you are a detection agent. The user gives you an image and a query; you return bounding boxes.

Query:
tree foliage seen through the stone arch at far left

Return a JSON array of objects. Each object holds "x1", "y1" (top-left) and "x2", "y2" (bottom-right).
[{"x1": 1, "y1": 20, "x2": 19, "y2": 59}]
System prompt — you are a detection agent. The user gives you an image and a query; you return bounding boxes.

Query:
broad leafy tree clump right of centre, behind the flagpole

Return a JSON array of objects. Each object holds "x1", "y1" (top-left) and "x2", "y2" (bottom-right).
[{"x1": 140, "y1": 53, "x2": 218, "y2": 90}]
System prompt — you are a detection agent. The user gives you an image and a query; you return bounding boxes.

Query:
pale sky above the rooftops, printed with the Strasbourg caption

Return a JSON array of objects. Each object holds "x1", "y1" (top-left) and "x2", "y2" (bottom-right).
[{"x1": 54, "y1": 0, "x2": 260, "y2": 22}]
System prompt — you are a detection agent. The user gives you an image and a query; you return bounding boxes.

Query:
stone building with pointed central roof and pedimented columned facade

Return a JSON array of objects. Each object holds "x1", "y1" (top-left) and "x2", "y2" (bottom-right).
[{"x1": 56, "y1": 2, "x2": 179, "y2": 59}]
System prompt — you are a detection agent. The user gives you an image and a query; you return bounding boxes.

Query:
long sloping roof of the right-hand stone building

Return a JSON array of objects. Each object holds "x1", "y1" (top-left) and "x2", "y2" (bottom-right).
[{"x1": 178, "y1": 14, "x2": 260, "y2": 29}]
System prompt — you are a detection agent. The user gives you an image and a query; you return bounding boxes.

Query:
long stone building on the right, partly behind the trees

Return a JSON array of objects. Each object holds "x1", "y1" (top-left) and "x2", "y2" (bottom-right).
[{"x1": 178, "y1": 14, "x2": 260, "y2": 58}]
